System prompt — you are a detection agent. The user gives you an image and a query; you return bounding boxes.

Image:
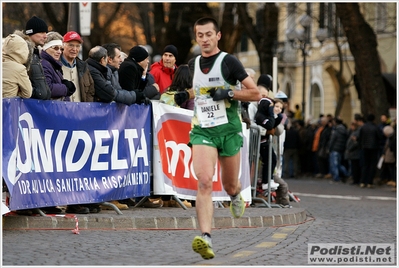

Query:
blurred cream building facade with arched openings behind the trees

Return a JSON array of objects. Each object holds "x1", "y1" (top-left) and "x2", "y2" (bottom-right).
[{"x1": 238, "y1": 2, "x2": 397, "y2": 124}]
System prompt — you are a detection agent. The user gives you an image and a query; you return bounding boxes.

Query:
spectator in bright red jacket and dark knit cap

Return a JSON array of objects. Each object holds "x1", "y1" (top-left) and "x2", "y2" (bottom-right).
[{"x1": 150, "y1": 45, "x2": 177, "y2": 94}]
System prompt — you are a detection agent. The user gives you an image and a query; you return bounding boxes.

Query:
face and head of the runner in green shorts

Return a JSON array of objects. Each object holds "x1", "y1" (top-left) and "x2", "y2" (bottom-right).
[{"x1": 195, "y1": 23, "x2": 221, "y2": 54}]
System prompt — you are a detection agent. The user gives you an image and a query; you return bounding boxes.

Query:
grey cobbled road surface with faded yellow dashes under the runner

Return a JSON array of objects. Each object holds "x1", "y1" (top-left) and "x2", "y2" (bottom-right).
[{"x1": 2, "y1": 178, "x2": 397, "y2": 267}]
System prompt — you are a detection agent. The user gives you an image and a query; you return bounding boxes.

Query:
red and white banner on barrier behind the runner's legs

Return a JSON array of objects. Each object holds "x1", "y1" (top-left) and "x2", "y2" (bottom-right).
[{"x1": 152, "y1": 101, "x2": 251, "y2": 202}]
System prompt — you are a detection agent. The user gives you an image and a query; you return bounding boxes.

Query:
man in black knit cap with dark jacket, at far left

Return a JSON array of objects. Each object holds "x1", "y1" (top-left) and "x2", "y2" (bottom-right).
[{"x1": 15, "y1": 16, "x2": 51, "y2": 100}]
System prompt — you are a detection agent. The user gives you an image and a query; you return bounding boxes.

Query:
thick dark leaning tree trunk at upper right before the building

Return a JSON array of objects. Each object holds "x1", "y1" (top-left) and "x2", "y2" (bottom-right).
[{"x1": 336, "y1": 3, "x2": 389, "y2": 118}]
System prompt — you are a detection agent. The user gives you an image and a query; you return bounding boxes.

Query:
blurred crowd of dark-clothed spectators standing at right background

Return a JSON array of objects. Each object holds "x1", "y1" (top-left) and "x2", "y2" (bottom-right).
[{"x1": 283, "y1": 112, "x2": 396, "y2": 190}]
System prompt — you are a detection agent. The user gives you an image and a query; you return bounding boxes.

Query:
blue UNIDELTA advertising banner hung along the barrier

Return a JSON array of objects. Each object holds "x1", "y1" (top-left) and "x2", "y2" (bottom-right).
[{"x1": 2, "y1": 98, "x2": 152, "y2": 210}]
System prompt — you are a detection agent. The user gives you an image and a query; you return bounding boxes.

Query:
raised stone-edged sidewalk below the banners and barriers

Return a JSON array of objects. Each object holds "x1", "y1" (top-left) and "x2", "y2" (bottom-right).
[{"x1": 3, "y1": 207, "x2": 307, "y2": 230}]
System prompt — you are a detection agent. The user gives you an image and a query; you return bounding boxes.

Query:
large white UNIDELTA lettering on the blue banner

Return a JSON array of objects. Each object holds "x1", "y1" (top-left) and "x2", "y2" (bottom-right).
[{"x1": 9, "y1": 114, "x2": 149, "y2": 174}]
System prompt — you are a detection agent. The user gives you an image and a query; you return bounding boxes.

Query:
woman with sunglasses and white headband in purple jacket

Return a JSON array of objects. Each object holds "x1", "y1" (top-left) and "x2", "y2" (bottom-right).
[{"x1": 41, "y1": 32, "x2": 76, "y2": 101}]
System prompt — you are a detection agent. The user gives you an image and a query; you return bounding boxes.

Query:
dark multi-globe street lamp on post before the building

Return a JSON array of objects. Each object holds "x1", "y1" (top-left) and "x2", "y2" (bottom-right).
[{"x1": 286, "y1": 14, "x2": 327, "y2": 120}]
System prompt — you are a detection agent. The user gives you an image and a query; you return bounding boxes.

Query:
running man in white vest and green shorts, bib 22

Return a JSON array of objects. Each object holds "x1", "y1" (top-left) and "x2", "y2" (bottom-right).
[{"x1": 175, "y1": 18, "x2": 261, "y2": 259}]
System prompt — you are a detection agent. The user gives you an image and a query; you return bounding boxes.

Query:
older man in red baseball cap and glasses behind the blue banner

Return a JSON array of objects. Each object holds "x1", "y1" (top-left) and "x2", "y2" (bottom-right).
[{"x1": 60, "y1": 31, "x2": 94, "y2": 102}]
